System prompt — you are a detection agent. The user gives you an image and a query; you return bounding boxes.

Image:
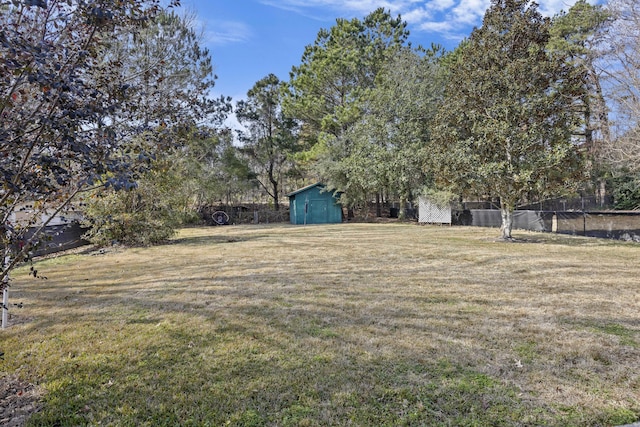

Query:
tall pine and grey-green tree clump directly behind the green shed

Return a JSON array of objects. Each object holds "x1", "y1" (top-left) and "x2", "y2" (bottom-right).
[{"x1": 284, "y1": 9, "x2": 422, "y2": 206}]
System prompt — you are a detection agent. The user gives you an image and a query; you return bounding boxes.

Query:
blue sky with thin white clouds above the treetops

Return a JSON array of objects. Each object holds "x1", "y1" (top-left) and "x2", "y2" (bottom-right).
[{"x1": 181, "y1": 0, "x2": 596, "y2": 101}]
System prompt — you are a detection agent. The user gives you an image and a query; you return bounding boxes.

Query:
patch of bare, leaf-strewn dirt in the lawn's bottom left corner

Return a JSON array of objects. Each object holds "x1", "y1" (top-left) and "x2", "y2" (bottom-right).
[{"x1": 0, "y1": 373, "x2": 41, "y2": 427}]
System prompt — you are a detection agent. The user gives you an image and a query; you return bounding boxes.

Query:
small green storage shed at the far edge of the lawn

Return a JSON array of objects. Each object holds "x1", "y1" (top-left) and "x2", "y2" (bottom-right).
[{"x1": 287, "y1": 183, "x2": 342, "y2": 224}]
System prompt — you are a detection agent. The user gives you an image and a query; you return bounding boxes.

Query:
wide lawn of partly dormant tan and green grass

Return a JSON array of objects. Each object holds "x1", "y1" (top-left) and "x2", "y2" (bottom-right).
[{"x1": 0, "y1": 224, "x2": 640, "y2": 426}]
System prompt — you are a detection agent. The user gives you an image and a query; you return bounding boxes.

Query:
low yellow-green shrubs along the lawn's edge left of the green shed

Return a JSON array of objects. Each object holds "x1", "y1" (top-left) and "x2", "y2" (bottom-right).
[{"x1": 85, "y1": 129, "x2": 253, "y2": 246}]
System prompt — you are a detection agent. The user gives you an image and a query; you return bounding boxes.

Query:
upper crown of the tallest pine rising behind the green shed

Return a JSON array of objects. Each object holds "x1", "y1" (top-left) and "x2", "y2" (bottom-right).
[{"x1": 285, "y1": 9, "x2": 408, "y2": 136}]
